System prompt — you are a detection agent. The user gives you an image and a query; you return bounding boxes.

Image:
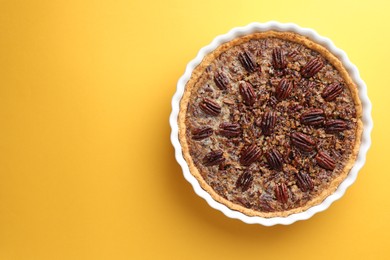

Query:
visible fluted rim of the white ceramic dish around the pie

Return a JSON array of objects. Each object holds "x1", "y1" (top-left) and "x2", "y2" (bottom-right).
[{"x1": 169, "y1": 21, "x2": 373, "y2": 226}]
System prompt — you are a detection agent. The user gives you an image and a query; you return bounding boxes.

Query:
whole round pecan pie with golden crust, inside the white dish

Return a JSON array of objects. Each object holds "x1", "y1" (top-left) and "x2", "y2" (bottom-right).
[{"x1": 179, "y1": 31, "x2": 362, "y2": 218}]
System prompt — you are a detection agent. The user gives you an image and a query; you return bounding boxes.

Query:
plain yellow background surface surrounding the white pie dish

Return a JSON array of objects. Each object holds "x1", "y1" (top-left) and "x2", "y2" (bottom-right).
[{"x1": 0, "y1": 0, "x2": 390, "y2": 260}]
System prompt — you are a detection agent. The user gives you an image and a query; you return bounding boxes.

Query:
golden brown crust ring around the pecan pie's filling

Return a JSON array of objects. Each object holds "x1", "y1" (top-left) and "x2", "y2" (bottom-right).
[{"x1": 178, "y1": 31, "x2": 363, "y2": 218}]
